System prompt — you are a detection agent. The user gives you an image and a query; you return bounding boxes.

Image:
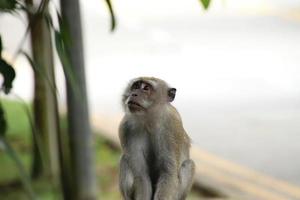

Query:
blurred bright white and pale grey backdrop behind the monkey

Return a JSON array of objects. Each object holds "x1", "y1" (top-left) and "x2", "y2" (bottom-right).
[{"x1": 0, "y1": 0, "x2": 300, "y2": 199}]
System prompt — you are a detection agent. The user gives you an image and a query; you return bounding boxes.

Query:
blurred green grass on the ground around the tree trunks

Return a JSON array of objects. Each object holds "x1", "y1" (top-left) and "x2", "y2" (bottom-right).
[{"x1": 0, "y1": 100, "x2": 121, "y2": 200}]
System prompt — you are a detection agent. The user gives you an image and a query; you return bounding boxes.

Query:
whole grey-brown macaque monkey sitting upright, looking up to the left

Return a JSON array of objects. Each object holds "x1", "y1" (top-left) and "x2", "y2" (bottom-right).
[{"x1": 119, "y1": 77, "x2": 195, "y2": 200}]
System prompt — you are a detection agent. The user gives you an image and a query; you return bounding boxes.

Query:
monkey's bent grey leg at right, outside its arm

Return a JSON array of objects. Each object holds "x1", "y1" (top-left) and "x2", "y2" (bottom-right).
[{"x1": 178, "y1": 159, "x2": 195, "y2": 200}]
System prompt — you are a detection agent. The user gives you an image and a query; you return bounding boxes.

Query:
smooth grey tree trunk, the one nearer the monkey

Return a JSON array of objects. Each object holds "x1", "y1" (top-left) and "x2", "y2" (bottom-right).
[{"x1": 61, "y1": 0, "x2": 97, "y2": 200}]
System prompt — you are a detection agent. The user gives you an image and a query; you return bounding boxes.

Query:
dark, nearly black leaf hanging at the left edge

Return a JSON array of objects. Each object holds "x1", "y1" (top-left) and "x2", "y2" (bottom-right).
[{"x1": 0, "y1": 58, "x2": 16, "y2": 94}]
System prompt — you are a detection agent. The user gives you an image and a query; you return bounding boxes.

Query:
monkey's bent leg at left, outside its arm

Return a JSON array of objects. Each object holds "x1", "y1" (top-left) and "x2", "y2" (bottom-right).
[{"x1": 119, "y1": 156, "x2": 133, "y2": 200}]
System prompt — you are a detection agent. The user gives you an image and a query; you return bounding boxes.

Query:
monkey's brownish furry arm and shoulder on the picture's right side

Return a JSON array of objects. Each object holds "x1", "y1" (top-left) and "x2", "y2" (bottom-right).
[{"x1": 154, "y1": 114, "x2": 188, "y2": 200}]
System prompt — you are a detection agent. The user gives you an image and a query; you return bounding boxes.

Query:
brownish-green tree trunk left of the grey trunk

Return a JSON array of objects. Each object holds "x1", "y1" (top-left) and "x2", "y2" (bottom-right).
[{"x1": 26, "y1": 0, "x2": 59, "y2": 183}]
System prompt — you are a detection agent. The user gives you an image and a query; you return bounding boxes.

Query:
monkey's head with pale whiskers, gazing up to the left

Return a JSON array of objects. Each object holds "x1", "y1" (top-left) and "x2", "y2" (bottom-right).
[{"x1": 122, "y1": 77, "x2": 176, "y2": 113}]
